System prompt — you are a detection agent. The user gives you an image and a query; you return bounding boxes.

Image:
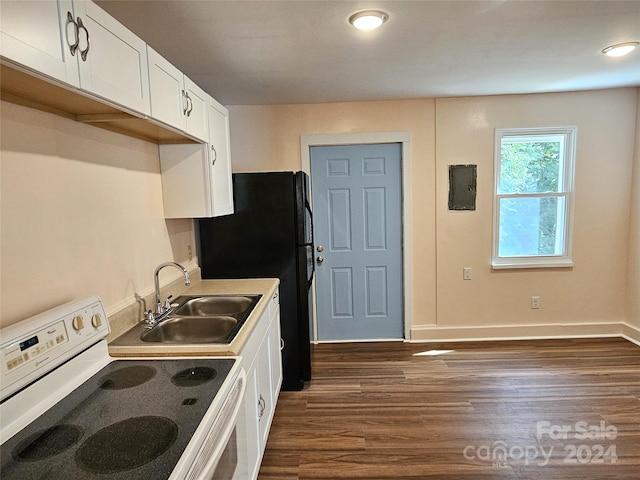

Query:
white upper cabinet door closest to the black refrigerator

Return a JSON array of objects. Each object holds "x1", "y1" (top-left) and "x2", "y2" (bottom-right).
[{"x1": 209, "y1": 98, "x2": 233, "y2": 217}]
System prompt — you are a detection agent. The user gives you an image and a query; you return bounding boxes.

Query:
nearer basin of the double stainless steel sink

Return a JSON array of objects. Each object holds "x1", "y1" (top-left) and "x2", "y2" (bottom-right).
[{"x1": 140, "y1": 315, "x2": 238, "y2": 343}]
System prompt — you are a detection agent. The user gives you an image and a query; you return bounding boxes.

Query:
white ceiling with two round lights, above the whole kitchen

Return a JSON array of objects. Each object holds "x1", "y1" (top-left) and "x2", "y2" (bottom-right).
[{"x1": 96, "y1": 0, "x2": 640, "y2": 105}]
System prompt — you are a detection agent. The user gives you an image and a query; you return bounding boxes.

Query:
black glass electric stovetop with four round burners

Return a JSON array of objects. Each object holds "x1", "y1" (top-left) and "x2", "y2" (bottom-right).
[{"x1": 0, "y1": 358, "x2": 235, "y2": 480}]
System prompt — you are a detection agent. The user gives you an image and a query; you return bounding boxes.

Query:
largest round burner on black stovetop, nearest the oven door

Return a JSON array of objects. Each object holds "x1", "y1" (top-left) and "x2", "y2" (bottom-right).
[{"x1": 76, "y1": 417, "x2": 178, "y2": 473}]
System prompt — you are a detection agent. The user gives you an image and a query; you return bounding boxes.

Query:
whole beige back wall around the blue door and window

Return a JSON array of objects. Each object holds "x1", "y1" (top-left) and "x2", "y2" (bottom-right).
[{"x1": 230, "y1": 89, "x2": 637, "y2": 339}]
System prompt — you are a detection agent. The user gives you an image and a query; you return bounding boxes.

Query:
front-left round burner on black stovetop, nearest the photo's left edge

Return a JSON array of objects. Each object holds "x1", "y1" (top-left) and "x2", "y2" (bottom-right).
[{"x1": 11, "y1": 425, "x2": 82, "y2": 462}]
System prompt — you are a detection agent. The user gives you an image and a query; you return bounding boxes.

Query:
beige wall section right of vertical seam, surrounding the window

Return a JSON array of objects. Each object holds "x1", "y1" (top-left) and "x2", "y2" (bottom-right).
[{"x1": 436, "y1": 89, "x2": 637, "y2": 335}]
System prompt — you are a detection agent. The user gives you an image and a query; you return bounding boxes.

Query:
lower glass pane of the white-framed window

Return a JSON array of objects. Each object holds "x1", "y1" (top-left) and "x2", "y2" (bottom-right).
[{"x1": 498, "y1": 197, "x2": 565, "y2": 257}]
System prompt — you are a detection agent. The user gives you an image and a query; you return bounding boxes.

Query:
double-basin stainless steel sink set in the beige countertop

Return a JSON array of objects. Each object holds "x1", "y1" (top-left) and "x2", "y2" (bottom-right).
[{"x1": 115, "y1": 295, "x2": 261, "y2": 344}]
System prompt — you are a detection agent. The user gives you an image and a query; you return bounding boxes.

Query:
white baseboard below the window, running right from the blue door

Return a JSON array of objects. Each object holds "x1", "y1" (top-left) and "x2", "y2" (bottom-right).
[{"x1": 409, "y1": 322, "x2": 640, "y2": 345}]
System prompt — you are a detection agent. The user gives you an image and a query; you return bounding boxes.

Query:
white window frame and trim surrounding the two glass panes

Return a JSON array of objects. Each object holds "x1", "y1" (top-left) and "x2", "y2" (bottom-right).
[{"x1": 491, "y1": 126, "x2": 577, "y2": 270}]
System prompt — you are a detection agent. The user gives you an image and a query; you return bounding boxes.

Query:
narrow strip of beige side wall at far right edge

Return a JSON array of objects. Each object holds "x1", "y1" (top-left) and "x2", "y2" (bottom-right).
[{"x1": 627, "y1": 94, "x2": 640, "y2": 329}]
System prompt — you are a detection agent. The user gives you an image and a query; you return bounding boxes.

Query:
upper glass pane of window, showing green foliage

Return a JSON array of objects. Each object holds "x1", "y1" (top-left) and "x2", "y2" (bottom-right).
[{"x1": 498, "y1": 135, "x2": 563, "y2": 193}]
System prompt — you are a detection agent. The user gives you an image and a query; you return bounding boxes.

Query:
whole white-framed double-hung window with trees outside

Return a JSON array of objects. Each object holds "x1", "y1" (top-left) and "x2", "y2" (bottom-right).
[{"x1": 492, "y1": 127, "x2": 576, "y2": 268}]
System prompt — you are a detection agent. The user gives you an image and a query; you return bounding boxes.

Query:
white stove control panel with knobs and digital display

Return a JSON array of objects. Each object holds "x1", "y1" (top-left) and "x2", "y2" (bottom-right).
[{"x1": 0, "y1": 296, "x2": 109, "y2": 399}]
